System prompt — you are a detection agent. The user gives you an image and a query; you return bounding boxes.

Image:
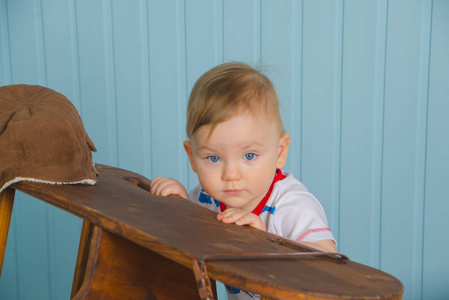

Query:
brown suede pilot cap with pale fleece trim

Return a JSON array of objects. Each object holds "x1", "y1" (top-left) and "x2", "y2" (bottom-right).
[{"x1": 0, "y1": 84, "x2": 97, "y2": 192}]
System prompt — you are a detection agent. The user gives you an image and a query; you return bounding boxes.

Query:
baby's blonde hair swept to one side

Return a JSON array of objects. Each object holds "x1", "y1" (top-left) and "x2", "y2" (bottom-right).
[{"x1": 186, "y1": 62, "x2": 285, "y2": 138}]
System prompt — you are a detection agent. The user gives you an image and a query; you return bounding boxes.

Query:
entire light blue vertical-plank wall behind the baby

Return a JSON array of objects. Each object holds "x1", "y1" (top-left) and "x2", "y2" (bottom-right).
[{"x1": 0, "y1": 0, "x2": 449, "y2": 300}]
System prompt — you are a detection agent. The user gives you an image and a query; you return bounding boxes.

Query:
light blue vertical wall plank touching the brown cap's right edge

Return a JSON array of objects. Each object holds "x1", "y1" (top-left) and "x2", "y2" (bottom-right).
[{"x1": 75, "y1": 0, "x2": 117, "y2": 165}]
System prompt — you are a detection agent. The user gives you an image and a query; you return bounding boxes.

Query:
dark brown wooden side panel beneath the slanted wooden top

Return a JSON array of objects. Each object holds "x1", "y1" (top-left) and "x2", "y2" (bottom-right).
[{"x1": 73, "y1": 226, "x2": 198, "y2": 300}]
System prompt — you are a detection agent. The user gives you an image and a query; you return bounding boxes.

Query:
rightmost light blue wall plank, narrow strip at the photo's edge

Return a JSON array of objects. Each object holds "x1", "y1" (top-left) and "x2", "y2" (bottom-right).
[{"x1": 423, "y1": 1, "x2": 449, "y2": 299}]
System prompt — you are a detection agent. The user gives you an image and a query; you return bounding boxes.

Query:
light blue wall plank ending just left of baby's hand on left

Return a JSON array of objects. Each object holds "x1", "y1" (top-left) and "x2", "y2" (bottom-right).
[{"x1": 112, "y1": 1, "x2": 150, "y2": 175}]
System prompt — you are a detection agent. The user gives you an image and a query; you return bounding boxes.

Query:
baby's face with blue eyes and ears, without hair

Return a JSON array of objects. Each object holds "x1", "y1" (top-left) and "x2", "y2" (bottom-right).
[{"x1": 185, "y1": 113, "x2": 290, "y2": 211}]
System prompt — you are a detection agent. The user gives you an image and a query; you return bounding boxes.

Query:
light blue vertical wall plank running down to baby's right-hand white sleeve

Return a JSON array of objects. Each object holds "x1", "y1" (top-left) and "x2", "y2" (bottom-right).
[{"x1": 301, "y1": 1, "x2": 341, "y2": 234}]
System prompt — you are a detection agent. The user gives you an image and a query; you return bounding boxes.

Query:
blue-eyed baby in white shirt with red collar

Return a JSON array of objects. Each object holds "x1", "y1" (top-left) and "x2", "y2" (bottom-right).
[{"x1": 150, "y1": 63, "x2": 336, "y2": 299}]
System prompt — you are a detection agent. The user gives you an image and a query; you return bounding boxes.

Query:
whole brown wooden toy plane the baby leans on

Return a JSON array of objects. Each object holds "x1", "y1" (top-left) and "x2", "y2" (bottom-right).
[{"x1": 0, "y1": 164, "x2": 403, "y2": 300}]
